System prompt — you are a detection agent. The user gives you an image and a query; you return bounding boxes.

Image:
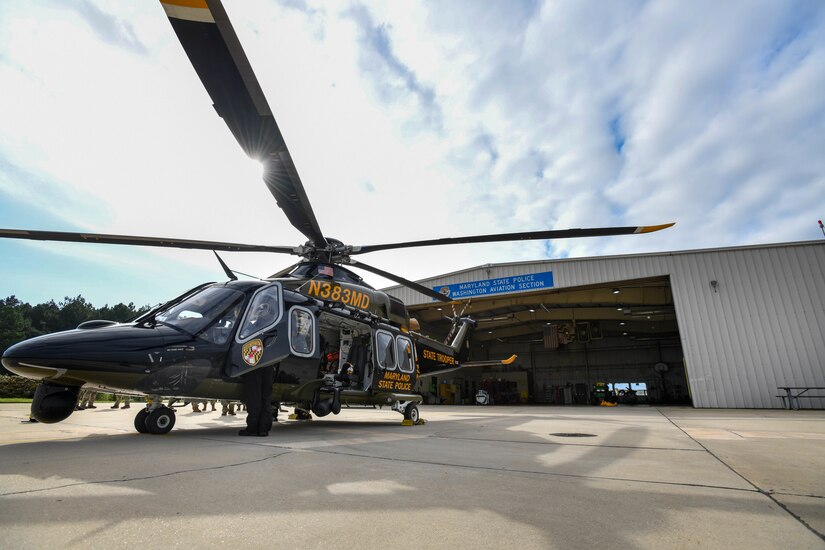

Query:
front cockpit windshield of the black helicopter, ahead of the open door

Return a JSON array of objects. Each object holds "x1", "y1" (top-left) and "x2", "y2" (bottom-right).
[{"x1": 155, "y1": 287, "x2": 244, "y2": 344}]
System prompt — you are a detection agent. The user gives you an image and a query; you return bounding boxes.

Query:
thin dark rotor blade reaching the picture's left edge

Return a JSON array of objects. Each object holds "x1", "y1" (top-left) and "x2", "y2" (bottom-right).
[{"x1": 0, "y1": 229, "x2": 296, "y2": 254}]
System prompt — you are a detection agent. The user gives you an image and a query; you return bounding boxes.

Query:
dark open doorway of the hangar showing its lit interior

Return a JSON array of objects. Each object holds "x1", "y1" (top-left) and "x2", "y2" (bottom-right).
[{"x1": 409, "y1": 276, "x2": 691, "y2": 405}]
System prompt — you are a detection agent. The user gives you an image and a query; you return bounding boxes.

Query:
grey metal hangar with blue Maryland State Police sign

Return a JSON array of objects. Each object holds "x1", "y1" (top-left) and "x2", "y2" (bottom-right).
[{"x1": 384, "y1": 241, "x2": 825, "y2": 408}]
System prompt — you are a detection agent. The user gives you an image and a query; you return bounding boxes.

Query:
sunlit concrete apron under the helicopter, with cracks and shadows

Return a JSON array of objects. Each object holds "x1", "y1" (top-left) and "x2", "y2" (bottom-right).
[{"x1": 0, "y1": 404, "x2": 825, "y2": 549}]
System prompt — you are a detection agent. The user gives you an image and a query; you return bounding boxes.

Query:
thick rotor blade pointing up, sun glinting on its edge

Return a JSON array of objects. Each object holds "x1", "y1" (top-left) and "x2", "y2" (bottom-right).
[{"x1": 161, "y1": 0, "x2": 327, "y2": 246}]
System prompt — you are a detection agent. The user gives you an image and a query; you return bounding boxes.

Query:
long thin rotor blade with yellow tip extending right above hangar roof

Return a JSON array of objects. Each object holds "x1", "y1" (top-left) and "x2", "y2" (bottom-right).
[{"x1": 350, "y1": 223, "x2": 674, "y2": 254}]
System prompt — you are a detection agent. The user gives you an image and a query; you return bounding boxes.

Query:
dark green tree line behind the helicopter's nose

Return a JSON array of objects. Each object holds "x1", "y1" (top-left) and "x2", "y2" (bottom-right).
[{"x1": 0, "y1": 296, "x2": 149, "y2": 374}]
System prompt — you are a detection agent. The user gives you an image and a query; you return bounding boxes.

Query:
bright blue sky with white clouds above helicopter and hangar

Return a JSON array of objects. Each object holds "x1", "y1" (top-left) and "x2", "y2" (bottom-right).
[{"x1": 0, "y1": 0, "x2": 825, "y2": 307}]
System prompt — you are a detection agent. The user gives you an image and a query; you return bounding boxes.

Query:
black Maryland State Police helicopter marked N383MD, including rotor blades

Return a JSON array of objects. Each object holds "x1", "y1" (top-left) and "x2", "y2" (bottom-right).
[{"x1": 0, "y1": 0, "x2": 673, "y2": 434}]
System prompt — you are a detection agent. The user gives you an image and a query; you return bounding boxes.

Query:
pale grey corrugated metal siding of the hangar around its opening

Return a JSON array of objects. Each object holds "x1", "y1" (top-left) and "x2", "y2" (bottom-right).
[{"x1": 388, "y1": 241, "x2": 825, "y2": 408}]
